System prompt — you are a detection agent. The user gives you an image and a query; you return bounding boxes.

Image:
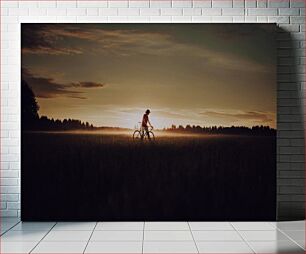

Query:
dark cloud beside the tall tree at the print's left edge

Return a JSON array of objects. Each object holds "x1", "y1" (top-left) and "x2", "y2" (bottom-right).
[{"x1": 22, "y1": 68, "x2": 105, "y2": 99}]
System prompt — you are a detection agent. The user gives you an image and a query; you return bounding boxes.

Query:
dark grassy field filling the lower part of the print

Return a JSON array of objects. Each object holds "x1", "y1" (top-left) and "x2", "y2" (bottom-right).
[{"x1": 21, "y1": 133, "x2": 276, "y2": 221}]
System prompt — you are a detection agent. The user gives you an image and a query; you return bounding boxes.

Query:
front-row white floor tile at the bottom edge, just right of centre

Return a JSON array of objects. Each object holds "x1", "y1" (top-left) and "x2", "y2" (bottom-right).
[{"x1": 143, "y1": 241, "x2": 198, "y2": 254}]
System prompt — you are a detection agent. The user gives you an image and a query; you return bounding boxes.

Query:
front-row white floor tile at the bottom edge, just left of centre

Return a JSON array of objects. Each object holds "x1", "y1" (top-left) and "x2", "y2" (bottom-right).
[{"x1": 85, "y1": 242, "x2": 142, "y2": 253}]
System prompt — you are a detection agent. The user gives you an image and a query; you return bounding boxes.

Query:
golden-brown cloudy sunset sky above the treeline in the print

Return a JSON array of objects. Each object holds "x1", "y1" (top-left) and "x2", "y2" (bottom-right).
[{"x1": 22, "y1": 24, "x2": 276, "y2": 128}]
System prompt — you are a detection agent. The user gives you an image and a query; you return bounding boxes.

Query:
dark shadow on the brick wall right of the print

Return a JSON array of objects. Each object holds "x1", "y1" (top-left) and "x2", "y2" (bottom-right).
[{"x1": 277, "y1": 28, "x2": 305, "y2": 220}]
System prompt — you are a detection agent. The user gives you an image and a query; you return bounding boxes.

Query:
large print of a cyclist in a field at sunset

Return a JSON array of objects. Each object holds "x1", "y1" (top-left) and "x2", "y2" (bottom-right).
[{"x1": 21, "y1": 24, "x2": 276, "y2": 221}]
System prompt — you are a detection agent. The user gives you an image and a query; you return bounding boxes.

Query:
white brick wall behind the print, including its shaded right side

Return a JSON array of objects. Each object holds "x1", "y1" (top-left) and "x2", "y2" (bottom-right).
[{"x1": 0, "y1": 0, "x2": 305, "y2": 219}]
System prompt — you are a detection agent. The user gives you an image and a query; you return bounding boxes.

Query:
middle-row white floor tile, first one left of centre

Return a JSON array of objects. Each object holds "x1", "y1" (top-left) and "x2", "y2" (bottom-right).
[{"x1": 90, "y1": 230, "x2": 143, "y2": 242}]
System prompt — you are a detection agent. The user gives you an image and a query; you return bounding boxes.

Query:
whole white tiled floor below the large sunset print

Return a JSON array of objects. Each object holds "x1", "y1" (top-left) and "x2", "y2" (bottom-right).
[{"x1": 0, "y1": 218, "x2": 305, "y2": 254}]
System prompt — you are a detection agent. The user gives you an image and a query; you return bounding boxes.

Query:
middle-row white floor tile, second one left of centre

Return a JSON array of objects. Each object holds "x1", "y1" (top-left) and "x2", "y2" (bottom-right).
[{"x1": 42, "y1": 230, "x2": 92, "y2": 242}]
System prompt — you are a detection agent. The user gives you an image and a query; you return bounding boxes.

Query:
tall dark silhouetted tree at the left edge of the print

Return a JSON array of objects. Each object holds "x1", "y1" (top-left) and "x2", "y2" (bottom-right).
[{"x1": 21, "y1": 80, "x2": 39, "y2": 129}]
